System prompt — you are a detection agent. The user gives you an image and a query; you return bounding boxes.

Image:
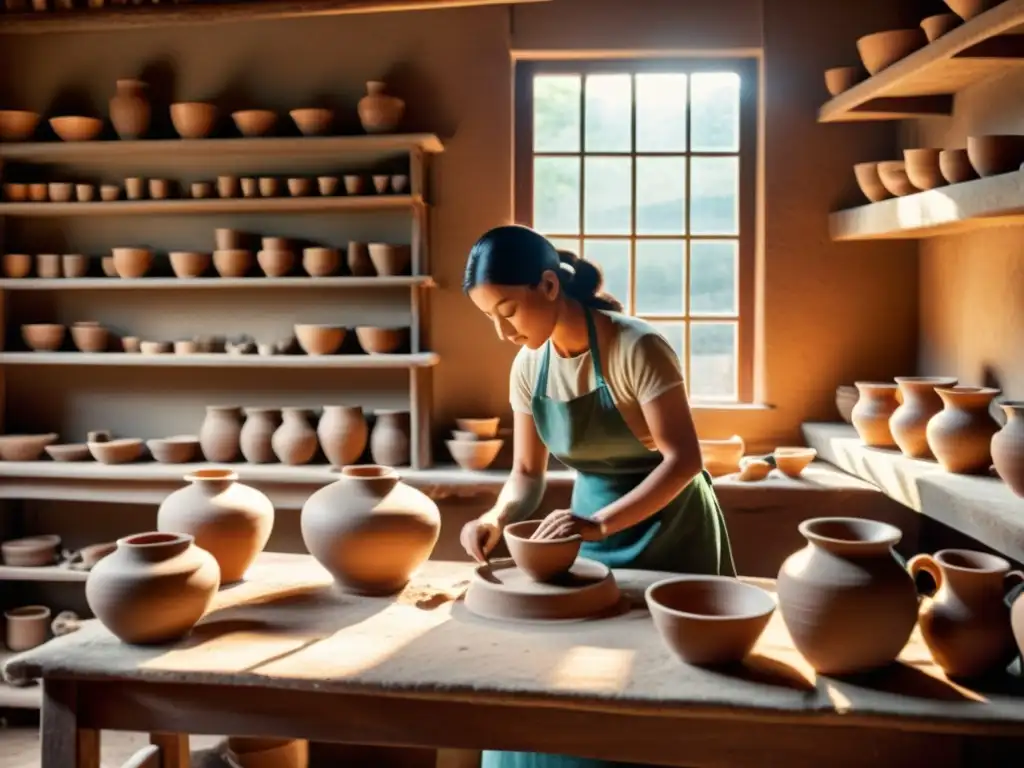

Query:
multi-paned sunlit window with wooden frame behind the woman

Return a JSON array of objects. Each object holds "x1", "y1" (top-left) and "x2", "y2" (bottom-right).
[{"x1": 516, "y1": 59, "x2": 757, "y2": 402}]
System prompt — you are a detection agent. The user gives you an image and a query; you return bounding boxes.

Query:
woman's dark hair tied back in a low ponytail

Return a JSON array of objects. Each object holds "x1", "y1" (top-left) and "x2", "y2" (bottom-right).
[{"x1": 462, "y1": 224, "x2": 623, "y2": 312}]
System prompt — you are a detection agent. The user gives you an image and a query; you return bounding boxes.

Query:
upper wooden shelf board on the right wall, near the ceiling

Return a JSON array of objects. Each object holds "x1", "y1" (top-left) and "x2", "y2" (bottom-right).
[{"x1": 818, "y1": 0, "x2": 1024, "y2": 123}]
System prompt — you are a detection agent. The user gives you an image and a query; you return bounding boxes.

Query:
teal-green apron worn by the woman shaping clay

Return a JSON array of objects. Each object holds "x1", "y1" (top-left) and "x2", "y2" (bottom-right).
[{"x1": 481, "y1": 310, "x2": 736, "y2": 768}]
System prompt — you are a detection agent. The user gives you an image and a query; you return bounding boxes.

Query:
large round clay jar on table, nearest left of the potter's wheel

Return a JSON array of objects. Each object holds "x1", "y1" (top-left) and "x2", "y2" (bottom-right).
[{"x1": 300, "y1": 465, "x2": 441, "y2": 595}]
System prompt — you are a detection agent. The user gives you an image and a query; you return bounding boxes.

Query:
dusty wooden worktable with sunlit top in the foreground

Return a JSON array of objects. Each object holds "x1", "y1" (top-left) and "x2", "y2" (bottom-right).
[{"x1": 6, "y1": 555, "x2": 1024, "y2": 768}]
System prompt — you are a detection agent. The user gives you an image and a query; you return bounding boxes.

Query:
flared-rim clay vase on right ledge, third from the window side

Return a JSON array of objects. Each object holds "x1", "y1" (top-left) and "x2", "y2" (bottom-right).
[{"x1": 927, "y1": 387, "x2": 999, "y2": 474}]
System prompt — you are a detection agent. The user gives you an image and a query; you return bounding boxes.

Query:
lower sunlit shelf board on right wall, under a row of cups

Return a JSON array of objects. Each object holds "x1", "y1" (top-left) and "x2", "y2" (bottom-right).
[{"x1": 828, "y1": 166, "x2": 1024, "y2": 241}]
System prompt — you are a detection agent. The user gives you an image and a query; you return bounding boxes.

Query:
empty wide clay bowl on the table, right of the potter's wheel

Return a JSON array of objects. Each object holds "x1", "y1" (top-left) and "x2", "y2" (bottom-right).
[{"x1": 644, "y1": 575, "x2": 775, "y2": 667}]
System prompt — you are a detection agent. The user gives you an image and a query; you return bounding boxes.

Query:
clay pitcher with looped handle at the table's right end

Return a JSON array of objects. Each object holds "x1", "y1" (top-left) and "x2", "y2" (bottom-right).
[{"x1": 906, "y1": 549, "x2": 1024, "y2": 678}]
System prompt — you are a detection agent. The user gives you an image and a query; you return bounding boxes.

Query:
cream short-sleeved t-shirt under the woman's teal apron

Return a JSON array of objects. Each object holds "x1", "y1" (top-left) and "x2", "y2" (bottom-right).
[{"x1": 509, "y1": 310, "x2": 683, "y2": 451}]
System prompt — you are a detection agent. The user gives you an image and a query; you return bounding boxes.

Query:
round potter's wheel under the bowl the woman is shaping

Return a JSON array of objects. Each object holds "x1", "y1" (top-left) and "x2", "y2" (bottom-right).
[{"x1": 465, "y1": 558, "x2": 620, "y2": 622}]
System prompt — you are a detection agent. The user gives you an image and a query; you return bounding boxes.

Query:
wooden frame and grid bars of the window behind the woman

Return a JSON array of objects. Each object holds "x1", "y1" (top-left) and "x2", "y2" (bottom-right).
[{"x1": 513, "y1": 56, "x2": 760, "y2": 408}]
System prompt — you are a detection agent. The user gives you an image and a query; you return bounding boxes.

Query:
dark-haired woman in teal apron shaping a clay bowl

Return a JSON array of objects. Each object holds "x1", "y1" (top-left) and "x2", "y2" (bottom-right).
[{"x1": 461, "y1": 226, "x2": 735, "y2": 768}]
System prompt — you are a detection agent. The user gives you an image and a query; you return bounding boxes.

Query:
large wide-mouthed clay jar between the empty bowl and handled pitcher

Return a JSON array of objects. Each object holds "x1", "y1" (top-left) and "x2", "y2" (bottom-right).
[{"x1": 776, "y1": 517, "x2": 918, "y2": 675}]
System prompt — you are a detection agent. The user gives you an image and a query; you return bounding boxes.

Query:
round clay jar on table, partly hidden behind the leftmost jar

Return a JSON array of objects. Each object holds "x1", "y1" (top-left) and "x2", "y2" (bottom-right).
[{"x1": 157, "y1": 469, "x2": 273, "y2": 584}]
